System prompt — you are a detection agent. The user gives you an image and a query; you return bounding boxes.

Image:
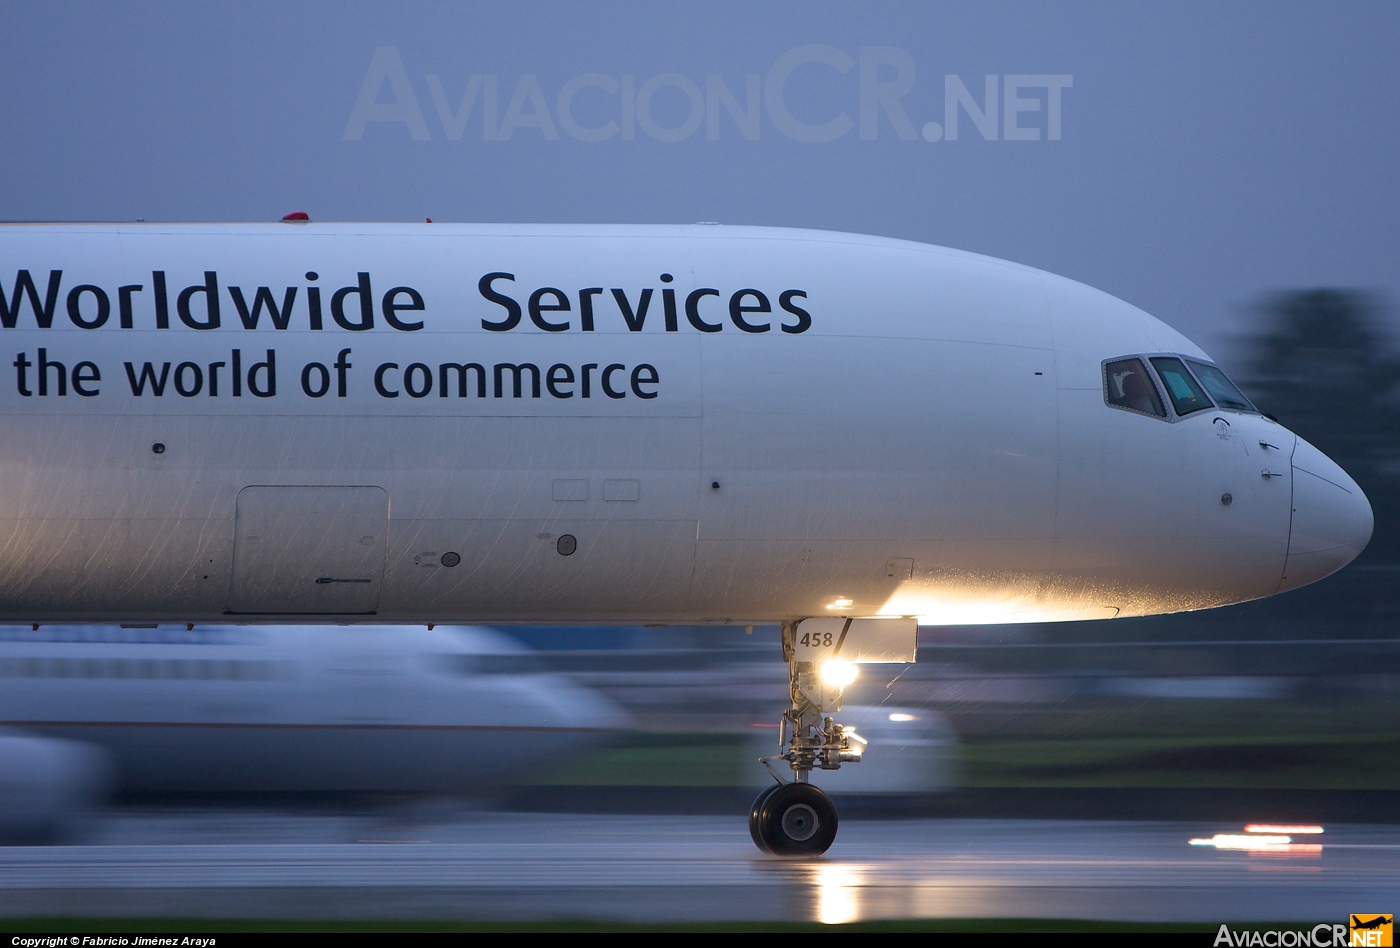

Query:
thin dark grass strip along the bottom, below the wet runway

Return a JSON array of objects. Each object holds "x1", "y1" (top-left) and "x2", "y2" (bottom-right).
[{"x1": 0, "y1": 917, "x2": 1254, "y2": 935}]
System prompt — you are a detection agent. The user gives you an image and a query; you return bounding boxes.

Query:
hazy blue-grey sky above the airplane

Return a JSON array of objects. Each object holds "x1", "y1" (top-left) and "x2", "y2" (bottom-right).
[{"x1": 0, "y1": 1, "x2": 1400, "y2": 367}]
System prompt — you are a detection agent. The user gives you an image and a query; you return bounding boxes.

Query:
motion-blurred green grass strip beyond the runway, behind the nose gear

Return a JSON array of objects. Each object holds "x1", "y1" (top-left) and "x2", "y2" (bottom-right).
[{"x1": 524, "y1": 699, "x2": 1400, "y2": 790}]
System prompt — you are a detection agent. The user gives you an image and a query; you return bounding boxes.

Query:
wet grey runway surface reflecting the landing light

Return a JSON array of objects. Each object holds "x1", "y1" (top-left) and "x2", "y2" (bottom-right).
[{"x1": 0, "y1": 811, "x2": 1400, "y2": 923}]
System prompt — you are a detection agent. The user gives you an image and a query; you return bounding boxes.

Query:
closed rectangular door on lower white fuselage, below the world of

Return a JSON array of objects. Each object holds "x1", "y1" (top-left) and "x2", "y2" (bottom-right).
[{"x1": 228, "y1": 487, "x2": 389, "y2": 615}]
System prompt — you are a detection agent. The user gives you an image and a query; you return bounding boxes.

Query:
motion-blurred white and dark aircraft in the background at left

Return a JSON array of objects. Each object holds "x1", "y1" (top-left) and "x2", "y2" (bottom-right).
[{"x1": 0, "y1": 626, "x2": 629, "y2": 839}]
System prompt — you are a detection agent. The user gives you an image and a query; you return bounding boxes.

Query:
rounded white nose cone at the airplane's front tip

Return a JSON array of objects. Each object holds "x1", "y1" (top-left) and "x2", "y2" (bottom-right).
[{"x1": 1278, "y1": 438, "x2": 1375, "y2": 592}]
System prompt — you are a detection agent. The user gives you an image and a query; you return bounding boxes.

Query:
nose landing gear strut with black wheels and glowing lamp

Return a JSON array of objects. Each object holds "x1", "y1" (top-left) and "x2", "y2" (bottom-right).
[{"x1": 749, "y1": 622, "x2": 865, "y2": 856}]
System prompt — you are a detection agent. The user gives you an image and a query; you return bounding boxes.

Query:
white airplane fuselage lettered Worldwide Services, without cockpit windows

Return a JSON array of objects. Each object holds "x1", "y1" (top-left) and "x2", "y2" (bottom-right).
[{"x1": 0, "y1": 224, "x2": 1371, "y2": 623}]
